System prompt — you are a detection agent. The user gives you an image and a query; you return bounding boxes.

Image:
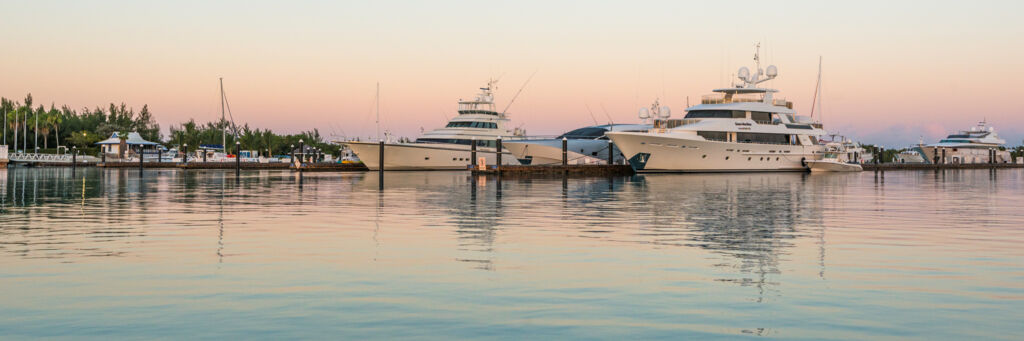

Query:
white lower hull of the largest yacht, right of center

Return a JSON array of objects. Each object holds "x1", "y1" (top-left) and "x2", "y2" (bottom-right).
[{"x1": 608, "y1": 132, "x2": 824, "y2": 172}]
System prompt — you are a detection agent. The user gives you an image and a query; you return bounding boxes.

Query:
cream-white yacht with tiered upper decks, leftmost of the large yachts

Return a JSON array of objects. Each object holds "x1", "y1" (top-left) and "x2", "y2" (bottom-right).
[{"x1": 342, "y1": 81, "x2": 523, "y2": 170}]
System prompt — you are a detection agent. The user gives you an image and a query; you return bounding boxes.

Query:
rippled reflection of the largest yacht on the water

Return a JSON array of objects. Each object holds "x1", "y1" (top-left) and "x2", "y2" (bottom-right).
[{"x1": 632, "y1": 173, "x2": 824, "y2": 301}]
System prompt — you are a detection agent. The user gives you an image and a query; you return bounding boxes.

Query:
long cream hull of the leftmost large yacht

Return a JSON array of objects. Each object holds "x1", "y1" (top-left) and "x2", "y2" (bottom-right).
[{"x1": 344, "y1": 142, "x2": 519, "y2": 170}]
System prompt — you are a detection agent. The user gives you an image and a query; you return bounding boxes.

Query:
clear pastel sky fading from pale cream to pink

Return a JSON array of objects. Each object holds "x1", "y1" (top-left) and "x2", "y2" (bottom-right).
[{"x1": 0, "y1": 0, "x2": 1024, "y2": 146}]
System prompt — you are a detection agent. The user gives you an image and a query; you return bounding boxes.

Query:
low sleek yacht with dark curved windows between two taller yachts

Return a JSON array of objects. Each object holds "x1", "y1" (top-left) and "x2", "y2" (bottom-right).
[{"x1": 503, "y1": 124, "x2": 651, "y2": 165}]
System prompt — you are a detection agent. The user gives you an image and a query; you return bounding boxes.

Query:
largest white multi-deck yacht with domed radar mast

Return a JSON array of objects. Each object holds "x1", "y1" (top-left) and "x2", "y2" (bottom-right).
[{"x1": 607, "y1": 52, "x2": 825, "y2": 172}]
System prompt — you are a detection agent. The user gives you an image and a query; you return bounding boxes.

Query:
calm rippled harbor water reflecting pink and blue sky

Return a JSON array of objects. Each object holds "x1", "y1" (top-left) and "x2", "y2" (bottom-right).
[{"x1": 0, "y1": 169, "x2": 1024, "y2": 339}]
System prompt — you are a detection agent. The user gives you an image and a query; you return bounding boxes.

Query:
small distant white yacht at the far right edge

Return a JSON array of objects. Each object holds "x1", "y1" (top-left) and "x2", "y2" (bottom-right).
[{"x1": 915, "y1": 121, "x2": 1011, "y2": 164}]
